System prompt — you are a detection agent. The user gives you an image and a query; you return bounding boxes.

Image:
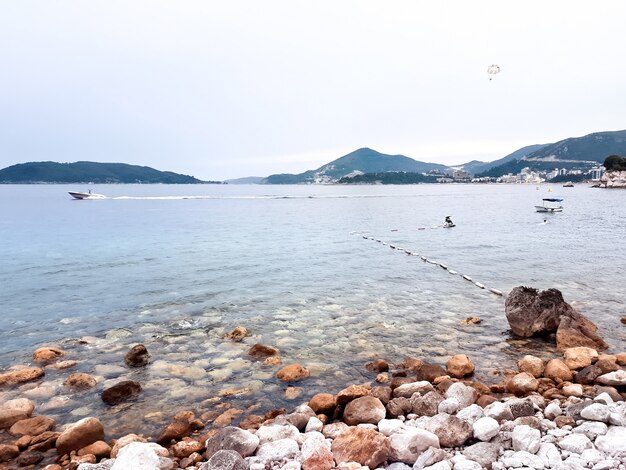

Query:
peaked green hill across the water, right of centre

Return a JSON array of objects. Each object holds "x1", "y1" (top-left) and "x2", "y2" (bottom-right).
[{"x1": 262, "y1": 148, "x2": 449, "y2": 184}]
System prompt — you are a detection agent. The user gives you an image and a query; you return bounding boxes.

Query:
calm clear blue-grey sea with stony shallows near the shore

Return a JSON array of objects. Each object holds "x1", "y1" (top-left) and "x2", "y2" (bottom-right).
[{"x1": 0, "y1": 184, "x2": 626, "y2": 436}]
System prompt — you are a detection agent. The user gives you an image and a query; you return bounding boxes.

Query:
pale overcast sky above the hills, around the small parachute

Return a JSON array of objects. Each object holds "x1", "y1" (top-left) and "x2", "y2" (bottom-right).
[{"x1": 0, "y1": 0, "x2": 626, "y2": 180}]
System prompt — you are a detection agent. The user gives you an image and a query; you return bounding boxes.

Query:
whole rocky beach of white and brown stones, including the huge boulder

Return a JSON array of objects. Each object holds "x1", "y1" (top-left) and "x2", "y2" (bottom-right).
[{"x1": 0, "y1": 287, "x2": 626, "y2": 470}]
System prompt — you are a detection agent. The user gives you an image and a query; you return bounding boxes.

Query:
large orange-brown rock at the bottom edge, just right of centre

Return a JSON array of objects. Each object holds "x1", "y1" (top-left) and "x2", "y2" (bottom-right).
[{"x1": 332, "y1": 427, "x2": 391, "y2": 470}]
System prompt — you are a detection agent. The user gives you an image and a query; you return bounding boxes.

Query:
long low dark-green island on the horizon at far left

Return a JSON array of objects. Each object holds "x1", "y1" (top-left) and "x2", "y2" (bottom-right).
[{"x1": 0, "y1": 162, "x2": 221, "y2": 184}]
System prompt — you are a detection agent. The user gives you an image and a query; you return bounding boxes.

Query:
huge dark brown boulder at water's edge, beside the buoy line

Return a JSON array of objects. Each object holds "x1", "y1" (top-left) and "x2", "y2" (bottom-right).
[{"x1": 505, "y1": 286, "x2": 608, "y2": 349}]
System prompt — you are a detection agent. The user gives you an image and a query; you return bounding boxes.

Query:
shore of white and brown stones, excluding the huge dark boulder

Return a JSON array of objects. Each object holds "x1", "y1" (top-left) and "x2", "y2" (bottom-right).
[{"x1": 0, "y1": 345, "x2": 626, "y2": 470}]
